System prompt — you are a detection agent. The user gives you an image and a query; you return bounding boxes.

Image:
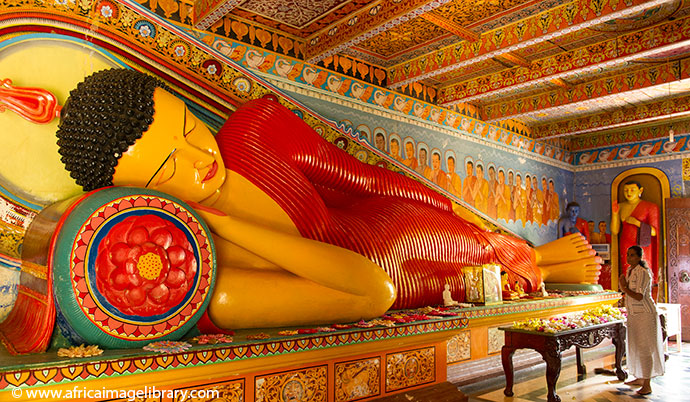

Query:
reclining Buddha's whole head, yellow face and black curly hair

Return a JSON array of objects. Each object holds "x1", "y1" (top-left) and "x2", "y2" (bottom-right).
[{"x1": 57, "y1": 69, "x2": 226, "y2": 202}]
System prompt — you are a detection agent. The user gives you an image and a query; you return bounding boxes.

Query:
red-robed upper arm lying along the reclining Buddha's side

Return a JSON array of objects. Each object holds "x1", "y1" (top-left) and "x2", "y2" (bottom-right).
[{"x1": 222, "y1": 99, "x2": 452, "y2": 211}]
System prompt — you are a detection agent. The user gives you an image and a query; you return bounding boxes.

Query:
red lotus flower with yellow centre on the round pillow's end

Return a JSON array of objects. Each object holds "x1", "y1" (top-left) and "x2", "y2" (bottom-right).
[{"x1": 95, "y1": 215, "x2": 197, "y2": 317}]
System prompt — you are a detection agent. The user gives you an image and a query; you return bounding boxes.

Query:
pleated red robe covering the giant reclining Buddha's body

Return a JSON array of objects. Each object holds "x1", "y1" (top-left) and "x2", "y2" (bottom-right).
[{"x1": 216, "y1": 99, "x2": 541, "y2": 309}]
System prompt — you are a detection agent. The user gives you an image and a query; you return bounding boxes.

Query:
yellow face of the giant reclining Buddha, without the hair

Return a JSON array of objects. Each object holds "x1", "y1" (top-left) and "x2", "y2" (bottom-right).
[{"x1": 113, "y1": 88, "x2": 226, "y2": 202}]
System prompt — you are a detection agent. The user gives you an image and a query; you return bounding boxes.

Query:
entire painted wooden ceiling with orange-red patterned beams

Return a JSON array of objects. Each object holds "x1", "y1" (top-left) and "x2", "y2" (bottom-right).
[{"x1": 179, "y1": 0, "x2": 690, "y2": 147}]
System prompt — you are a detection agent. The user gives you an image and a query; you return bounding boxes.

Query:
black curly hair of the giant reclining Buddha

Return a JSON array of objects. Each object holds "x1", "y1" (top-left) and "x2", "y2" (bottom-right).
[{"x1": 57, "y1": 69, "x2": 167, "y2": 191}]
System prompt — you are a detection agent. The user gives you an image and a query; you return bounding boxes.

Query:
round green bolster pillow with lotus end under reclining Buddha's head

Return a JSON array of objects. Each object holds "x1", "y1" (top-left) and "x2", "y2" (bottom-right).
[{"x1": 49, "y1": 187, "x2": 215, "y2": 348}]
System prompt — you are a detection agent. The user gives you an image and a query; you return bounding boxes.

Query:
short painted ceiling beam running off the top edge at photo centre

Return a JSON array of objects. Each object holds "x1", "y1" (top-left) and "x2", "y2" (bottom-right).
[{"x1": 306, "y1": 0, "x2": 453, "y2": 64}]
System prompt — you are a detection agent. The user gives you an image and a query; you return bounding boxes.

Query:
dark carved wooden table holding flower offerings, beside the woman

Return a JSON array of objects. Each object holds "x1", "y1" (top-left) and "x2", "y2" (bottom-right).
[{"x1": 499, "y1": 320, "x2": 628, "y2": 402}]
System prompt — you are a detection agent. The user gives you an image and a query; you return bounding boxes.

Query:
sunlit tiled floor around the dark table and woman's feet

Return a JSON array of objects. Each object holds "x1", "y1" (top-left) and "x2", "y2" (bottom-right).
[{"x1": 460, "y1": 343, "x2": 690, "y2": 402}]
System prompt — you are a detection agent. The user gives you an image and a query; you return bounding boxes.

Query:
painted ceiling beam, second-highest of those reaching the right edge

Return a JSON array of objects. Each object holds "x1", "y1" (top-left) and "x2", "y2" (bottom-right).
[{"x1": 484, "y1": 59, "x2": 690, "y2": 123}]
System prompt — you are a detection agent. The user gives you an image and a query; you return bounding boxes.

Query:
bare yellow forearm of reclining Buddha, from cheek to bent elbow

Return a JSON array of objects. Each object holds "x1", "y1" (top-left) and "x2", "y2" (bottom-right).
[{"x1": 193, "y1": 204, "x2": 395, "y2": 306}]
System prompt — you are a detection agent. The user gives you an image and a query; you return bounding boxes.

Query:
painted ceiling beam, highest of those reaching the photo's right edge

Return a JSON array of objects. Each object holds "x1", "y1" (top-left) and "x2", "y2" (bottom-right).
[{"x1": 438, "y1": 16, "x2": 690, "y2": 107}]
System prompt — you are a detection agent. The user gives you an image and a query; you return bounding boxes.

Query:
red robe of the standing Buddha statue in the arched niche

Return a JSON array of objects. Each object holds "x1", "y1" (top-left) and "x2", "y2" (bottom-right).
[{"x1": 618, "y1": 200, "x2": 661, "y2": 283}]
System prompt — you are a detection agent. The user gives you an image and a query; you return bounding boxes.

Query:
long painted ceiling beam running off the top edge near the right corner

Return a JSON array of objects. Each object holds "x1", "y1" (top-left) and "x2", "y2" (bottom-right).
[{"x1": 388, "y1": 0, "x2": 671, "y2": 89}]
